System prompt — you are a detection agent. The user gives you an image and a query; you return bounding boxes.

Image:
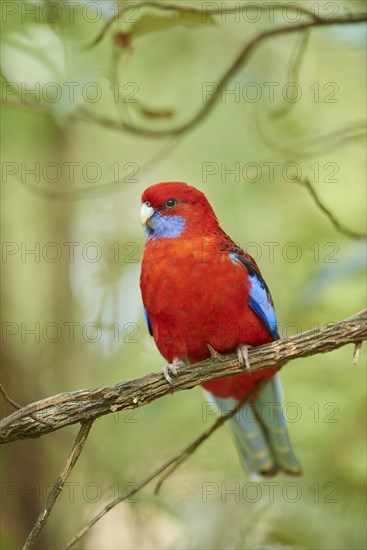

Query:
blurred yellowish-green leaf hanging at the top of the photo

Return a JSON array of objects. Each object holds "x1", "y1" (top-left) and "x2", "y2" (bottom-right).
[{"x1": 128, "y1": 11, "x2": 216, "y2": 38}]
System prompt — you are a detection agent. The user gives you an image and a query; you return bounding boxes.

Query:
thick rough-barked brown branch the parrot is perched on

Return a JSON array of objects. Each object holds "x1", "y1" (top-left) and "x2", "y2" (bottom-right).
[{"x1": 0, "y1": 310, "x2": 367, "y2": 443}]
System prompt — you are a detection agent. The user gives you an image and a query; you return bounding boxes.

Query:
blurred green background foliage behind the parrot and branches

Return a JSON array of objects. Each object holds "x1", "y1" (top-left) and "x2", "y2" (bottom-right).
[{"x1": 1, "y1": 0, "x2": 366, "y2": 549}]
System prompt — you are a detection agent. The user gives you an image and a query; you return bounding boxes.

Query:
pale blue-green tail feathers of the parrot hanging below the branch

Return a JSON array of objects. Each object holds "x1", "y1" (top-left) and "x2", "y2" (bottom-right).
[{"x1": 205, "y1": 375, "x2": 301, "y2": 477}]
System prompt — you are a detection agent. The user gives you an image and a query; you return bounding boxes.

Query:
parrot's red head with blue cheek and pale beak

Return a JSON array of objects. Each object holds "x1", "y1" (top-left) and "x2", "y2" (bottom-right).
[{"x1": 140, "y1": 182, "x2": 219, "y2": 239}]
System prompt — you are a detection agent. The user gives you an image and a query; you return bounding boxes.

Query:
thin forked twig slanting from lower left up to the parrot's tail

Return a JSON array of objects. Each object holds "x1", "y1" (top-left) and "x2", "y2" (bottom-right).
[{"x1": 62, "y1": 380, "x2": 267, "y2": 550}]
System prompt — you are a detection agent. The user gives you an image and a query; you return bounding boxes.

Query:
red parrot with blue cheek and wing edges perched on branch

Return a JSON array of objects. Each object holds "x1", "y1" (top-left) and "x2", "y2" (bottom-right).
[{"x1": 140, "y1": 182, "x2": 301, "y2": 476}]
